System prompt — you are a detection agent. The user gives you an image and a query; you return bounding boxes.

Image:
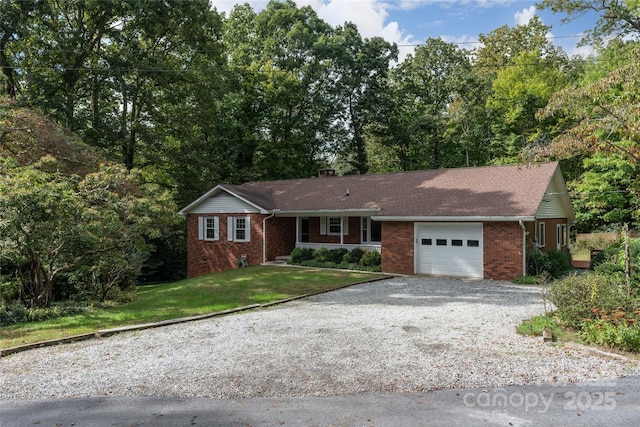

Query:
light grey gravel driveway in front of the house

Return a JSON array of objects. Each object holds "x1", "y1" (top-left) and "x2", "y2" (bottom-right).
[{"x1": 0, "y1": 277, "x2": 640, "y2": 399}]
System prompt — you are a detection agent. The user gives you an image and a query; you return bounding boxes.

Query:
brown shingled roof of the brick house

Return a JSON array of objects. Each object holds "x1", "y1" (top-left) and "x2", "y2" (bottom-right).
[{"x1": 183, "y1": 162, "x2": 572, "y2": 219}]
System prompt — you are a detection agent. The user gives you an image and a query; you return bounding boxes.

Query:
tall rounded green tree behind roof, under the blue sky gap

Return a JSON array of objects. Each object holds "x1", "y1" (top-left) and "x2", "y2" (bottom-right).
[{"x1": 369, "y1": 39, "x2": 471, "y2": 170}]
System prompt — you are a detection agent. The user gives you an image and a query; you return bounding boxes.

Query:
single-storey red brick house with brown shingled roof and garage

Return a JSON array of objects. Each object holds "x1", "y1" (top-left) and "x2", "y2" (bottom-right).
[{"x1": 180, "y1": 162, "x2": 575, "y2": 280}]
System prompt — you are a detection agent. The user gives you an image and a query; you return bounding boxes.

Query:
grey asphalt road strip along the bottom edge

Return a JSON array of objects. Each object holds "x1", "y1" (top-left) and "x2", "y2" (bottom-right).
[{"x1": 0, "y1": 377, "x2": 640, "y2": 427}]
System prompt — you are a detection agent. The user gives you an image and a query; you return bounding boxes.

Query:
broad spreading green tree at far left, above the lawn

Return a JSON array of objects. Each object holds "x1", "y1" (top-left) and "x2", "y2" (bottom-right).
[{"x1": 0, "y1": 157, "x2": 175, "y2": 307}]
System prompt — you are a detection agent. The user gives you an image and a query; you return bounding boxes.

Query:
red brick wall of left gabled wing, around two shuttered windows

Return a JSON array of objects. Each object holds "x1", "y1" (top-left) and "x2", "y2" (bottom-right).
[{"x1": 187, "y1": 214, "x2": 264, "y2": 277}]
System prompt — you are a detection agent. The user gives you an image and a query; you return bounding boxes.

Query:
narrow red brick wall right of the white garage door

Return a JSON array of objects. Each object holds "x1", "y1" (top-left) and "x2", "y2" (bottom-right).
[{"x1": 483, "y1": 222, "x2": 523, "y2": 280}]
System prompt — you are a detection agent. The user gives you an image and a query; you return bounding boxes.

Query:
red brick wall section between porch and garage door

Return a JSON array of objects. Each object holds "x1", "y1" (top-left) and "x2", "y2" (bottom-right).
[{"x1": 382, "y1": 221, "x2": 414, "y2": 274}]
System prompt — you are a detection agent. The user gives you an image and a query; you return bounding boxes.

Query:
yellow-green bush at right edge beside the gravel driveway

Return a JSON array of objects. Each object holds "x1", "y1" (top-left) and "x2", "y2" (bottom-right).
[{"x1": 546, "y1": 273, "x2": 634, "y2": 329}]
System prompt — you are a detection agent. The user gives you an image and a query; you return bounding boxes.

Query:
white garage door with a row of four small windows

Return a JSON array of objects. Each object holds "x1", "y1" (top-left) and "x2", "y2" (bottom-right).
[{"x1": 415, "y1": 222, "x2": 483, "y2": 278}]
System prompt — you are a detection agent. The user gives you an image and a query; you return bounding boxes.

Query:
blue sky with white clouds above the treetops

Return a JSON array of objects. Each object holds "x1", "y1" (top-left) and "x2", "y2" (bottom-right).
[{"x1": 211, "y1": 0, "x2": 596, "y2": 61}]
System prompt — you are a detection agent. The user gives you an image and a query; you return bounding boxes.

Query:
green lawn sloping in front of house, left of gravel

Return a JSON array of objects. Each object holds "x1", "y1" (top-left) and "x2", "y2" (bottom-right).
[{"x1": 0, "y1": 266, "x2": 385, "y2": 348}]
